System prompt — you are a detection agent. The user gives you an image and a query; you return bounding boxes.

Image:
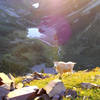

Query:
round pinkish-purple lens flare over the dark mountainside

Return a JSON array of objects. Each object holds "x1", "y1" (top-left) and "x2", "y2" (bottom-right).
[{"x1": 39, "y1": 16, "x2": 72, "y2": 46}]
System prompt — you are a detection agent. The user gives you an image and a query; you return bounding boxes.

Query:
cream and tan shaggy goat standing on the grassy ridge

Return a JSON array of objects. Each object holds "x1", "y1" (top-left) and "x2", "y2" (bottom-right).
[{"x1": 54, "y1": 61, "x2": 76, "y2": 75}]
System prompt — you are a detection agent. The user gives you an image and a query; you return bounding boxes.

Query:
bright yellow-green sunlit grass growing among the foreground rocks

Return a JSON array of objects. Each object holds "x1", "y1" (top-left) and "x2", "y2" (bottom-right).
[{"x1": 16, "y1": 69, "x2": 100, "y2": 100}]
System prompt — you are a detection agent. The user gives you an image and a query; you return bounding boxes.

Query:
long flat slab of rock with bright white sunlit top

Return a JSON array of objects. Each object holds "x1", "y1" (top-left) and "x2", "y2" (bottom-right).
[{"x1": 6, "y1": 86, "x2": 38, "y2": 100}]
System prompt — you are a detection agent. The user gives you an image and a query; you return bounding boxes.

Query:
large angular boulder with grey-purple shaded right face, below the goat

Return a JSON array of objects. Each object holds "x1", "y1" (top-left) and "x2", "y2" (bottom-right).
[{"x1": 45, "y1": 79, "x2": 66, "y2": 97}]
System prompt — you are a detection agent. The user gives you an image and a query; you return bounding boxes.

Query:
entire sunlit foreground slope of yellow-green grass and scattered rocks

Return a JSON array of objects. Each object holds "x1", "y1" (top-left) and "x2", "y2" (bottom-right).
[{"x1": 0, "y1": 68, "x2": 100, "y2": 100}]
